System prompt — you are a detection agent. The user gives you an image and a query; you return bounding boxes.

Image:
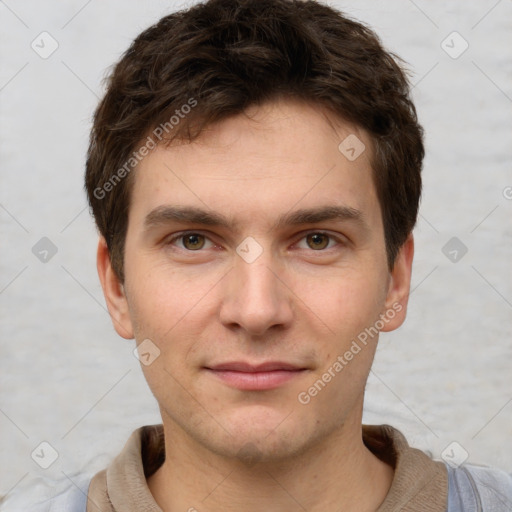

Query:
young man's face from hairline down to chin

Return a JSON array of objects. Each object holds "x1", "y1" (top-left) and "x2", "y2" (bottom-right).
[{"x1": 105, "y1": 101, "x2": 410, "y2": 459}]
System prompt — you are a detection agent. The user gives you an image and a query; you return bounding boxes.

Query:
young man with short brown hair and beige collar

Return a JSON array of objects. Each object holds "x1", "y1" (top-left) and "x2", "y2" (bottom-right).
[{"x1": 33, "y1": 0, "x2": 512, "y2": 512}]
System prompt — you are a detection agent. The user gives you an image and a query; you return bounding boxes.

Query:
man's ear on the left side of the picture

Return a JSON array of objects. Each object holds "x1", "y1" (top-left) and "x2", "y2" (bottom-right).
[{"x1": 96, "y1": 237, "x2": 134, "y2": 340}]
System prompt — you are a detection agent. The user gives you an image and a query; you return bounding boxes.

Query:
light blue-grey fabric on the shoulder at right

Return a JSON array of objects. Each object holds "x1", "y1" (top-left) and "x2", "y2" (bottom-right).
[{"x1": 446, "y1": 464, "x2": 512, "y2": 512}]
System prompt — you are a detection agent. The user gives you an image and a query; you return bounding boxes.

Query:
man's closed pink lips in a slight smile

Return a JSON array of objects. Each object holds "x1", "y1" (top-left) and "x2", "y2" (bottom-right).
[{"x1": 204, "y1": 361, "x2": 307, "y2": 391}]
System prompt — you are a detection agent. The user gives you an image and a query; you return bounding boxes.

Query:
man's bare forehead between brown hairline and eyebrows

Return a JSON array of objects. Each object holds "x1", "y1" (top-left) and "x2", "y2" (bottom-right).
[{"x1": 130, "y1": 100, "x2": 380, "y2": 232}]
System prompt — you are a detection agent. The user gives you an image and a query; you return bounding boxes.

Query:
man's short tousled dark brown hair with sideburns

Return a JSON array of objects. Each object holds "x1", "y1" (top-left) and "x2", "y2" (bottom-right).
[{"x1": 85, "y1": 0, "x2": 424, "y2": 281}]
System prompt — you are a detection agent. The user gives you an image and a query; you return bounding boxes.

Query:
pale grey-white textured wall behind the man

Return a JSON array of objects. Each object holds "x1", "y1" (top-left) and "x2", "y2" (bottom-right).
[{"x1": 0, "y1": 0, "x2": 512, "y2": 510}]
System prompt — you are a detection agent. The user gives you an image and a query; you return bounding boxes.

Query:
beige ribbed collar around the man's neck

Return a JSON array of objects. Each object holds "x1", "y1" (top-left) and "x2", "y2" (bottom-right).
[{"x1": 87, "y1": 425, "x2": 448, "y2": 512}]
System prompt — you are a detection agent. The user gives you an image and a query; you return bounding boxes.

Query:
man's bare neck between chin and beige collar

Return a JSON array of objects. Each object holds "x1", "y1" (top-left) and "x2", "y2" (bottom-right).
[{"x1": 148, "y1": 412, "x2": 393, "y2": 512}]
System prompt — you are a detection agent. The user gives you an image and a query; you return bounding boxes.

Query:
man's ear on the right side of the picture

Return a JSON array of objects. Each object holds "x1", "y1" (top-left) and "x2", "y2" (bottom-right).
[{"x1": 381, "y1": 234, "x2": 414, "y2": 332}]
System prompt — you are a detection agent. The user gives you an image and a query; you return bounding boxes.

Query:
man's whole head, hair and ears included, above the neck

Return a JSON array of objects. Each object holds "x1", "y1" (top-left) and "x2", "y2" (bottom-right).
[{"x1": 86, "y1": 0, "x2": 424, "y2": 464}]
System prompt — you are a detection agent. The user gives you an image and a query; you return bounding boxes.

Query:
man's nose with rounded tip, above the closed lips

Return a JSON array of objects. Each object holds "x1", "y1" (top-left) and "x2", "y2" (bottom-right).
[{"x1": 220, "y1": 251, "x2": 293, "y2": 336}]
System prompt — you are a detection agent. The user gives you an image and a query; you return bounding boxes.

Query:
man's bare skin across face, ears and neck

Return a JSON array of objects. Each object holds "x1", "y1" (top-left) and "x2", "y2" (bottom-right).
[{"x1": 98, "y1": 100, "x2": 413, "y2": 512}]
